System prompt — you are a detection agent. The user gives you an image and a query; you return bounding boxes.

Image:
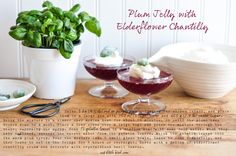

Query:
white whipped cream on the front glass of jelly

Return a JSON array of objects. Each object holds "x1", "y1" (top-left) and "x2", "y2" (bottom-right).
[{"x1": 129, "y1": 64, "x2": 160, "y2": 79}]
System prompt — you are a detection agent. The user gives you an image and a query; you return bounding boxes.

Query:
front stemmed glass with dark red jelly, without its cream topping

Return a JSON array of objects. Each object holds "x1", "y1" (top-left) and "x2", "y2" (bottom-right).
[{"x1": 117, "y1": 68, "x2": 173, "y2": 115}]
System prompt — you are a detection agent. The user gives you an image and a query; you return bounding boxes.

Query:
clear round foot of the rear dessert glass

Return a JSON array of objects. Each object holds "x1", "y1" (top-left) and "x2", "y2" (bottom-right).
[{"x1": 89, "y1": 85, "x2": 129, "y2": 98}]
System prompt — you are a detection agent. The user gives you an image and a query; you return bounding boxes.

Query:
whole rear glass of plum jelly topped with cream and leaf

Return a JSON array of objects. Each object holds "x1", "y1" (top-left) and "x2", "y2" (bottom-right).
[{"x1": 83, "y1": 47, "x2": 134, "y2": 98}]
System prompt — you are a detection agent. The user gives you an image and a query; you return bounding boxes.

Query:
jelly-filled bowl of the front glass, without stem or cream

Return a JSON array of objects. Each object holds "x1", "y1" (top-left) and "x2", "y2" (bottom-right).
[{"x1": 118, "y1": 69, "x2": 173, "y2": 95}]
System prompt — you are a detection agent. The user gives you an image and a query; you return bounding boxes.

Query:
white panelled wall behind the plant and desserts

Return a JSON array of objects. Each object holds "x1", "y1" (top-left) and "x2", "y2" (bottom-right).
[{"x1": 0, "y1": 0, "x2": 236, "y2": 78}]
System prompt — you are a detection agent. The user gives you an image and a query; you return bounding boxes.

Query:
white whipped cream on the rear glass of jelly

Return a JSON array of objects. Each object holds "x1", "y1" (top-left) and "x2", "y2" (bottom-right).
[{"x1": 94, "y1": 47, "x2": 123, "y2": 66}]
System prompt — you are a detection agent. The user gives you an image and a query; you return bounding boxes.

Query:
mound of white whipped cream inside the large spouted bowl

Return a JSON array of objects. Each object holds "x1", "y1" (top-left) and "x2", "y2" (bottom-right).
[{"x1": 182, "y1": 47, "x2": 229, "y2": 64}]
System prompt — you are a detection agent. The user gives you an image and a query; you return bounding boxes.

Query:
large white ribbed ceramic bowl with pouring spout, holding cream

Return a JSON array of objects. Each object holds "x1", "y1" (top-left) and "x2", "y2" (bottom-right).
[{"x1": 149, "y1": 43, "x2": 236, "y2": 99}]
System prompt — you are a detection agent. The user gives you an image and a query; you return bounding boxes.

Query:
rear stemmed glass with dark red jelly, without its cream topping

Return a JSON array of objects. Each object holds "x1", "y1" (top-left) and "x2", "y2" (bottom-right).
[{"x1": 83, "y1": 56, "x2": 134, "y2": 98}]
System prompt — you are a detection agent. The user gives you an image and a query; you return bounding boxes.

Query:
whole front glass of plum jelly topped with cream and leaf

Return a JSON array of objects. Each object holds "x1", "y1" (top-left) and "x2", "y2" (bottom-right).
[{"x1": 117, "y1": 59, "x2": 173, "y2": 115}]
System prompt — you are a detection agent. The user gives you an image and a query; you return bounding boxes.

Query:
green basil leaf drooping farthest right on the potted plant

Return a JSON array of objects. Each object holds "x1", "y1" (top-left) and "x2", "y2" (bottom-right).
[{"x1": 85, "y1": 17, "x2": 102, "y2": 37}]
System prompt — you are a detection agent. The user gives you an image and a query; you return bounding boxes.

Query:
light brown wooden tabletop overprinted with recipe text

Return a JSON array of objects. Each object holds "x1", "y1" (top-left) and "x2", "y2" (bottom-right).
[{"x1": 0, "y1": 80, "x2": 236, "y2": 156}]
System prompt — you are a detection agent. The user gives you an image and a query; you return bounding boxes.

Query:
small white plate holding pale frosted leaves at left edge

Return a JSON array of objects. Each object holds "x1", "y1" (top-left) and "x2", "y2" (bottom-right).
[{"x1": 0, "y1": 79, "x2": 36, "y2": 111}]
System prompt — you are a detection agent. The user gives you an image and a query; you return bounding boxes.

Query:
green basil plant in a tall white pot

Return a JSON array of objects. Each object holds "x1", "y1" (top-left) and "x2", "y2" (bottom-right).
[{"x1": 9, "y1": 1, "x2": 101, "y2": 99}]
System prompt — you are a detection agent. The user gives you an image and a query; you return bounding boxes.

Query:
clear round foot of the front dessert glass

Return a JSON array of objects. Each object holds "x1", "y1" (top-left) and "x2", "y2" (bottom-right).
[{"x1": 122, "y1": 99, "x2": 166, "y2": 115}]
